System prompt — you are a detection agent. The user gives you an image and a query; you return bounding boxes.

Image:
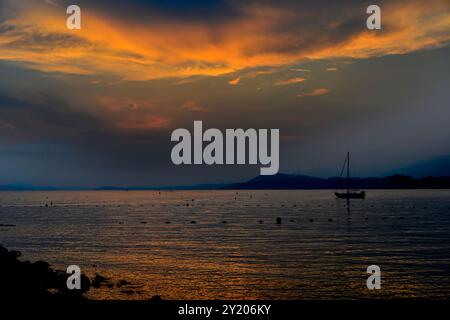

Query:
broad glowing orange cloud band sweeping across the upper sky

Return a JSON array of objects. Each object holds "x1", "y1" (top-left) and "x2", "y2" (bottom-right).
[{"x1": 0, "y1": 0, "x2": 450, "y2": 80}]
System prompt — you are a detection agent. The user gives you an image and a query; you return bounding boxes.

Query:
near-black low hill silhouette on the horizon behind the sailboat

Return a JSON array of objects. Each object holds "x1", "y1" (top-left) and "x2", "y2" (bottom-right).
[{"x1": 225, "y1": 174, "x2": 450, "y2": 189}]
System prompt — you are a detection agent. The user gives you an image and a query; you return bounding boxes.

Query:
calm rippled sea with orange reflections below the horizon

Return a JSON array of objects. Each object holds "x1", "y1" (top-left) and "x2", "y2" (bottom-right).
[{"x1": 0, "y1": 190, "x2": 450, "y2": 299}]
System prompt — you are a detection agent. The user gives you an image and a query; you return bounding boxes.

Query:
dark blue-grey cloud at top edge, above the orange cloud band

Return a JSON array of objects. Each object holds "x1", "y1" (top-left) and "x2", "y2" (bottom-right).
[{"x1": 65, "y1": 0, "x2": 368, "y2": 38}]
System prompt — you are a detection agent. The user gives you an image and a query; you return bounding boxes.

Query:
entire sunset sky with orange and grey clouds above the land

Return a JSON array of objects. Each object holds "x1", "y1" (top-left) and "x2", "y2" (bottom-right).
[{"x1": 0, "y1": 0, "x2": 450, "y2": 186}]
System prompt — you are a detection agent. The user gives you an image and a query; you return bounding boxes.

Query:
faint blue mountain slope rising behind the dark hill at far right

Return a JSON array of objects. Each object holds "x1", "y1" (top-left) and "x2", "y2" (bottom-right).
[{"x1": 390, "y1": 156, "x2": 450, "y2": 178}]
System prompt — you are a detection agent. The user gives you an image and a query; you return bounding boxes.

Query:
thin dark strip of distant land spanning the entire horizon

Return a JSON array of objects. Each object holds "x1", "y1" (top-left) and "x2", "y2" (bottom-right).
[{"x1": 0, "y1": 174, "x2": 450, "y2": 191}]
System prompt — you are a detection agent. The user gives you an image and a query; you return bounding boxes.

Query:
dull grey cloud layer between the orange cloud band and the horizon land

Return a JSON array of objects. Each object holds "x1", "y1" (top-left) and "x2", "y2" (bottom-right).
[{"x1": 0, "y1": 44, "x2": 449, "y2": 185}]
